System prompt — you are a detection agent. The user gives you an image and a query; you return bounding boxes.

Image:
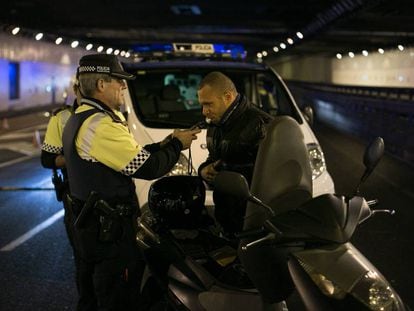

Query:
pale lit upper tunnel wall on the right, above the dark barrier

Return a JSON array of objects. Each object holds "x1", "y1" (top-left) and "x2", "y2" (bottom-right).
[{"x1": 268, "y1": 48, "x2": 414, "y2": 88}]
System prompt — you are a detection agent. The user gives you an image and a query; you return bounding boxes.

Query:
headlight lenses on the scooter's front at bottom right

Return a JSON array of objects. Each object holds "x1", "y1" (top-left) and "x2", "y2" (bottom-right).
[{"x1": 301, "y1": 262, "x2": 405, "y2": 311}]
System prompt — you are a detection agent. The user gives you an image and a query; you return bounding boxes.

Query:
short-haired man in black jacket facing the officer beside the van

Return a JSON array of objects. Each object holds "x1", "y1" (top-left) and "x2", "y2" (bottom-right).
[{"x1": 198, "y1": 72, "x2": 272, "y2": 238}]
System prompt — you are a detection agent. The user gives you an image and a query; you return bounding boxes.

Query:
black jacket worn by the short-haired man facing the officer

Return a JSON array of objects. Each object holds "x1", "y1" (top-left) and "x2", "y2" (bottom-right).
[{"x1": 198, "y1": 95, "x2": 272, "y2": 183}]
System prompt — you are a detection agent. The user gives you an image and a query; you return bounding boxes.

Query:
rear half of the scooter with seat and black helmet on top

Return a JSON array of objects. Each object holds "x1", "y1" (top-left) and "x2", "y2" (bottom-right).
[{"x1": 137, "y1": 176, "x2": 285, "y2": 311}]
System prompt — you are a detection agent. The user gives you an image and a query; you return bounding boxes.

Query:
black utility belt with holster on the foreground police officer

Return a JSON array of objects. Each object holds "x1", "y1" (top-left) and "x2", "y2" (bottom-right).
[{"x1": 69, "y1": 191, "x2": 137, "y2": 246}]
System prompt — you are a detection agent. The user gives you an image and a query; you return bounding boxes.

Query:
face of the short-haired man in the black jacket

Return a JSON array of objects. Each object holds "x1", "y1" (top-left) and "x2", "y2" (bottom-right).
[{"x1": 197, "y1": 85, "x2": 231, "y2": 124}]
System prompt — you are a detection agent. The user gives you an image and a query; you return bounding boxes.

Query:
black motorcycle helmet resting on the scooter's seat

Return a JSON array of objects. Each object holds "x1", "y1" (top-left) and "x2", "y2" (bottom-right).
[{"x1": 148, "y1": 175, "x2": 206, "y2": 229}]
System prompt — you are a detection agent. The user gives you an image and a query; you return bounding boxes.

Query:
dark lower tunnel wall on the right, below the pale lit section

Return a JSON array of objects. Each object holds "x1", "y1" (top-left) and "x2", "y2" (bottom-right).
[{"x1": 287, "y1": 81, "x2": 414, "y2": 165}]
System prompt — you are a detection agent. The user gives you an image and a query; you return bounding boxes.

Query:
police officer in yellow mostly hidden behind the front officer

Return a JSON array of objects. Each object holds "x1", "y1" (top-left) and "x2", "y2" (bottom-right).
[{"x1": 40, "y1": 77, "x2": 81, "y2": 252}]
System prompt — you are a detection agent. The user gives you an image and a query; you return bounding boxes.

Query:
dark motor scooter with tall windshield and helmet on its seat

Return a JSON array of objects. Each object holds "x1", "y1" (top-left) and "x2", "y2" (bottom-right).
[{"x1": 137, "y1": 117, "x2": 408, "y2": 311}]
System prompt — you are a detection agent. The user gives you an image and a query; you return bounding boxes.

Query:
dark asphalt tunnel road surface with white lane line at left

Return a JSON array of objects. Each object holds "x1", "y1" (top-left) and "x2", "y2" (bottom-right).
[{"x1": 0, "y1": 118, "x2": 414, "y2": 311}]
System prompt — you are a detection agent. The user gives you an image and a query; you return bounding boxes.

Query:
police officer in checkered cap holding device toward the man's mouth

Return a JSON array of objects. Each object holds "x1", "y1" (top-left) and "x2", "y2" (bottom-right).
[{"x1": 63, "y1": 54, "x2": 200, "y2": 310}]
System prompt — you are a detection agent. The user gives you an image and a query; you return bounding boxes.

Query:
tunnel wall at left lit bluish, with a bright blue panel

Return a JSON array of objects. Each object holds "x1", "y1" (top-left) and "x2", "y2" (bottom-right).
[{"x1": 0, "y1": 33, "x2": 85, "y2": 112}]
